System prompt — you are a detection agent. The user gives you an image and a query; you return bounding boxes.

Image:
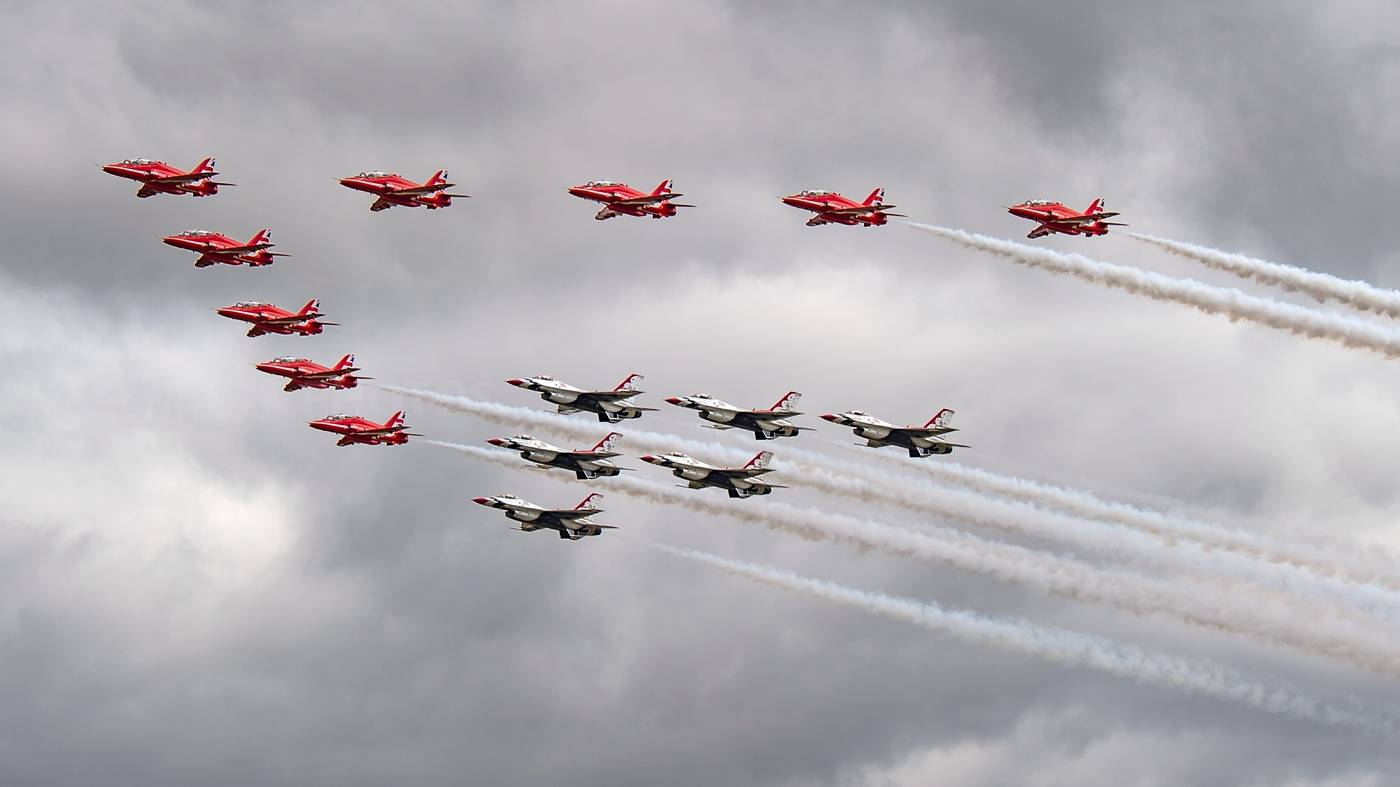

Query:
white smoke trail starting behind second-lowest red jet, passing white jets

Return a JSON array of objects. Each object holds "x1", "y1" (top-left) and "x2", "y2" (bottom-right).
[{"x1": 384, "y1": 385, "x2": 1400, "y2": 619}]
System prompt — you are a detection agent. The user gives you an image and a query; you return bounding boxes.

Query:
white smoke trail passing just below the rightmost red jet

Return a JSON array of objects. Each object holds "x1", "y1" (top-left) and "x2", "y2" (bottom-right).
[{"x1": 910, "y1": 223, "x2": 1400, "y2": 358}]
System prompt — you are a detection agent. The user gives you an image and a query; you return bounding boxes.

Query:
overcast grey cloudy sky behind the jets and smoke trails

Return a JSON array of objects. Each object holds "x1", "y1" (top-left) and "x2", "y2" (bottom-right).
[{"x1": 0, "y1": 0, "x2": 1400, "y2": 787}]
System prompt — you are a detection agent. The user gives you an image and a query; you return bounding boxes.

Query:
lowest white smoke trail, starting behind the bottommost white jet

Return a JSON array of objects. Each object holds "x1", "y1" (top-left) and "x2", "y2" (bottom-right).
[{"x1": 654, "y1": 543, "x2": 1397, "y2": 735}]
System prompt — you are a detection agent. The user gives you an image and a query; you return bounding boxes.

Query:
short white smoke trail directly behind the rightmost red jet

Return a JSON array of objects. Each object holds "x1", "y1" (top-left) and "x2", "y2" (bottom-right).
[{"x1": 1124, "y1": 232, "x2": 1400, "y2": 316}]
